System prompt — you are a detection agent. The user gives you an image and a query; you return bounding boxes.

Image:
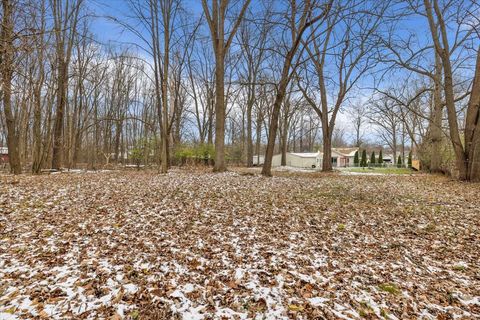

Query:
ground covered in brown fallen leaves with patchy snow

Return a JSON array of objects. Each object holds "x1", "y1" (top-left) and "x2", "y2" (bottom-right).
[{"x1": 0, "y1": 169, "x2": 480, "y2": 319}]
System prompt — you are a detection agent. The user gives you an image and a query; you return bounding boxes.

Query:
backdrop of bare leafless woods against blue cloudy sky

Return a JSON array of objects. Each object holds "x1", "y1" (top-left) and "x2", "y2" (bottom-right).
[{"x1": 0, "y1": 0, "x2": 480, "y2": 180}]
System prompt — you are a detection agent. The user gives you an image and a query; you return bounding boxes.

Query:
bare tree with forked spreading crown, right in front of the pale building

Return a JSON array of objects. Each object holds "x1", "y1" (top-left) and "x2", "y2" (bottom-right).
[{"x1": 299, "y1": 1, "x2": 388, "y2": 171}]
